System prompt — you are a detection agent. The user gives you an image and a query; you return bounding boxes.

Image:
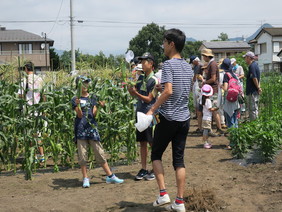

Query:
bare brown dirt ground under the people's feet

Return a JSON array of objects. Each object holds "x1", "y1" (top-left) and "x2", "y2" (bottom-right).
[{"x1": 0, "y1": 120, "x2": 282, "y2": 212}]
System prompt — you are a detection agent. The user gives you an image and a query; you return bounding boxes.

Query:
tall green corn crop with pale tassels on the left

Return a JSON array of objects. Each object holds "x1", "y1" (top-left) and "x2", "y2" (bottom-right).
[{"x1": 0, "y1": 62, "x2": 136, "y2": 179}]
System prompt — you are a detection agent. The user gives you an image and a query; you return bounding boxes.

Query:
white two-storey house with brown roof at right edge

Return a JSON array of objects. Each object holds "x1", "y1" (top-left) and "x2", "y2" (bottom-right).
[{"x1": 249, "y1": 27, "x2": 282, "y2": 71}]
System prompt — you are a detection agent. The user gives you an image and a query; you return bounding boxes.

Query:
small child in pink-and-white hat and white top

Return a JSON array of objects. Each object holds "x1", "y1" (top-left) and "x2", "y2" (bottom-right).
[{"x1": 201, "y1": 84, "x2": 218, "y2": 149}]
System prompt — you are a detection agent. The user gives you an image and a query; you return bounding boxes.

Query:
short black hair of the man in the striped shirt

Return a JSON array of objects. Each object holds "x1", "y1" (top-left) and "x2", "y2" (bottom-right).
[{"x1": 164, "y1": 28, "x2": 186, "y2": 53}]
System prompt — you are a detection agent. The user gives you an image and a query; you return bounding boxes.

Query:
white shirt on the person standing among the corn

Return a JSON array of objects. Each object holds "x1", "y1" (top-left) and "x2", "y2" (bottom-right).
[{"x1": 18, "y1": 74, "x2": 43, "y2": 105}]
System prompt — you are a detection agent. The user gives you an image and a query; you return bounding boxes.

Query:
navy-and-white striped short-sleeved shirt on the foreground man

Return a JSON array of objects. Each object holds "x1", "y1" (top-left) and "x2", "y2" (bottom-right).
[{"x1": 160, "y1": 58, "x2": 193, "y2": 121}]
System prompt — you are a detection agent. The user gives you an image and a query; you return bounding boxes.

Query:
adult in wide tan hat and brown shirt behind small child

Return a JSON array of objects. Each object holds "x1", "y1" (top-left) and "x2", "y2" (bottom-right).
[{"x1": 201, "y1": 49, "x2": 224, "y2": 134}]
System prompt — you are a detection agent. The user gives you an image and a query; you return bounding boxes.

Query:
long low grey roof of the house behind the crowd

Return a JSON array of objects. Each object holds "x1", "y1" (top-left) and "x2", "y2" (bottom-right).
[{"x1": 203, "y1": 41, "x2": 251, "y2": 49}]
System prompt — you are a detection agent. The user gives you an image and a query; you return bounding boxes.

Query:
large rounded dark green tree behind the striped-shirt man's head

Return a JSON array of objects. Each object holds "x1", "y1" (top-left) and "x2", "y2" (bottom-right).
[{"x1": 129, "y1": 23, "x2": 165, "y2": 63}]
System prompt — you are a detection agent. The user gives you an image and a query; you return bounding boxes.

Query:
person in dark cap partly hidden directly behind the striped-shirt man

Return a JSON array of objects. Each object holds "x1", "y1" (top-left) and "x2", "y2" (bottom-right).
[{"x1": 189, "y1": 56, "x2": 203, "y2": 133}]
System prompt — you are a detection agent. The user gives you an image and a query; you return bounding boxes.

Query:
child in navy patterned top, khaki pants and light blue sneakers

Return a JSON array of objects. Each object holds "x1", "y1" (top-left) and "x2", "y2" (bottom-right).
[{"x1": 72, "y1": 76, "x2": 124, "y2": 188}]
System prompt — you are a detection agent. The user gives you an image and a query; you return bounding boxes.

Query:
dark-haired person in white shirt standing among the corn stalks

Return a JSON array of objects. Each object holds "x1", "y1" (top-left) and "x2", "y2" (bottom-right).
[{"x1": 18, "y1": 62, "x2": 45, "y2": 162}]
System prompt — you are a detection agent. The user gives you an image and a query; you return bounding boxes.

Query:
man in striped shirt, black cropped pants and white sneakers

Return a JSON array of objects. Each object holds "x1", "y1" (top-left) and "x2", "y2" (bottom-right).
[{"x1": 147, "y1": 29, "x2": 193, "y2": 211}]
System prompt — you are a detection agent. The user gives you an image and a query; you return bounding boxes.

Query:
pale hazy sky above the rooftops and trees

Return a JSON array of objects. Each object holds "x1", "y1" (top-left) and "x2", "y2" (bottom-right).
[{"x1": 0, "y1": 0, "x2": 282, "y2": 55}]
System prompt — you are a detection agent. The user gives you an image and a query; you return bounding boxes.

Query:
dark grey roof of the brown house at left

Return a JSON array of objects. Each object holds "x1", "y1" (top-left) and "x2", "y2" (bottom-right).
[{"x1": 0, "y1": 28, "x2": 54, "y2": 46}]
